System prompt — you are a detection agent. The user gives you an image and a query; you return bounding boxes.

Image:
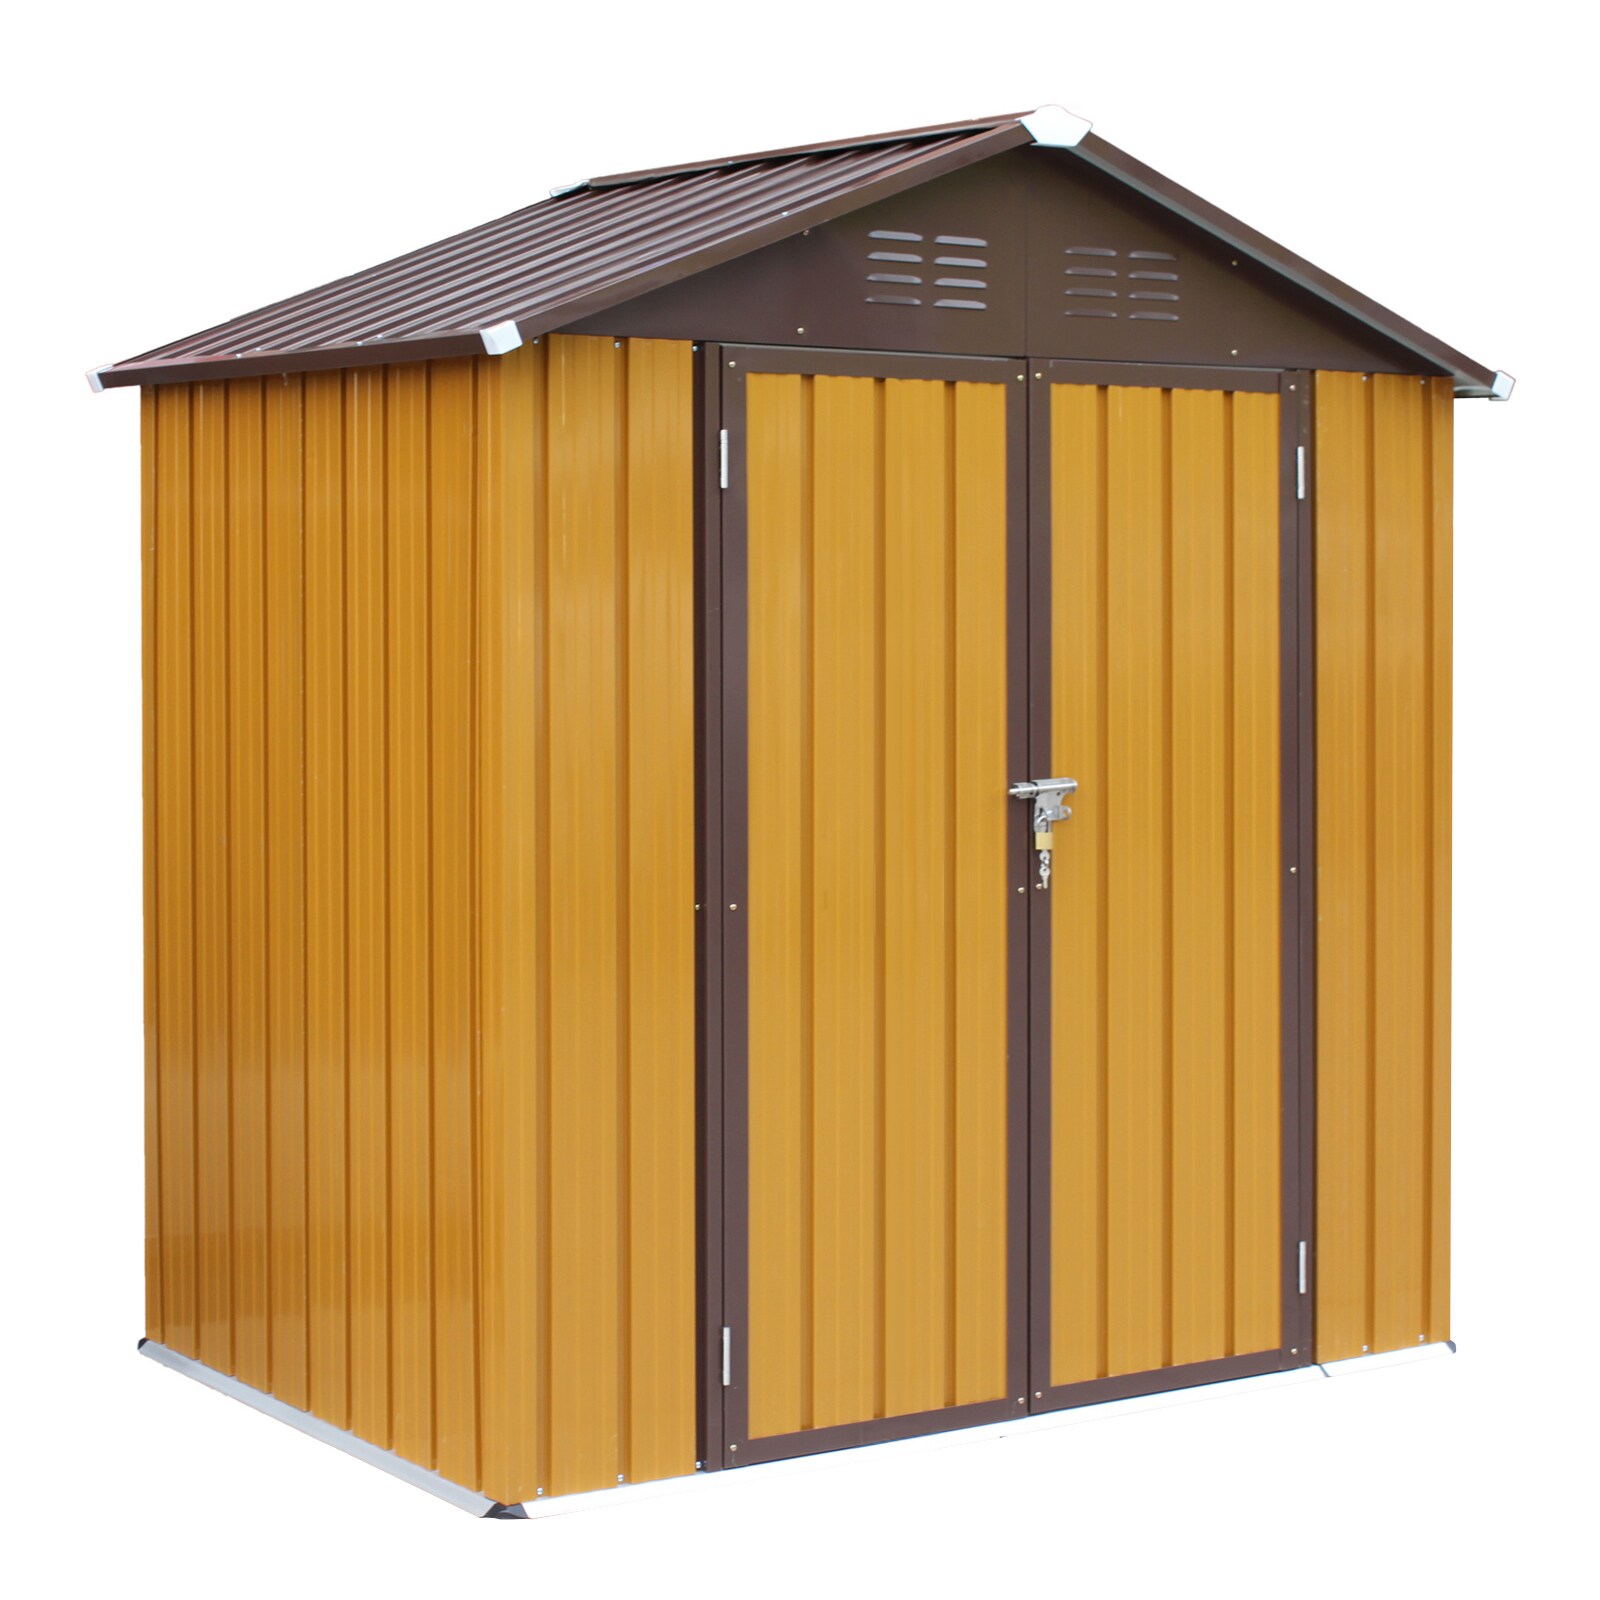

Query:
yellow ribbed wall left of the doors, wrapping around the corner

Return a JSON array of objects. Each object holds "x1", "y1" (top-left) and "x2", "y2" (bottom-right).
[{"x1": 144, "y1": 338, "x2": 694, "y2": 1501}]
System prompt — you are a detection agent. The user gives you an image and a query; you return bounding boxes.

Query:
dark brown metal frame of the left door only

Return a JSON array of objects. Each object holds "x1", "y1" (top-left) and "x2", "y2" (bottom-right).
[{"x1": 699, "y1": 344, "x2": 1030, "y2": 1469}]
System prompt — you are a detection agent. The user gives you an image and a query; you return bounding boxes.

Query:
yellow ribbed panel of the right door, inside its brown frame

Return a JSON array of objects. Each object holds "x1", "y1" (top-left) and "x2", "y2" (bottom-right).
[{"x1": 1050, "y1": 386, "x2": 1280, "y2": 1384}]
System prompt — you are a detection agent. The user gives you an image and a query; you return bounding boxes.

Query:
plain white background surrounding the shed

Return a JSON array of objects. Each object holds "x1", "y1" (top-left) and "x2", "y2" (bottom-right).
[{"x1": 0, "y1": 0, "x2": 1600, "y2": 1597}]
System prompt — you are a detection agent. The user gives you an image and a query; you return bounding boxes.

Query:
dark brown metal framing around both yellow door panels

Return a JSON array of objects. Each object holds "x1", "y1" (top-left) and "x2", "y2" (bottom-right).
[{"x1": 696, "y1": 342, "x2": 1315, "y2": 1470}]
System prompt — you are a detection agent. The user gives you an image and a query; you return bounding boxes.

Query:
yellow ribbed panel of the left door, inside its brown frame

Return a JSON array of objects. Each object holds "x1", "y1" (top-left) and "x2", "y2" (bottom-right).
[{"x1": 747, "y1": 374, "x2": 1008, "y2": 1437}]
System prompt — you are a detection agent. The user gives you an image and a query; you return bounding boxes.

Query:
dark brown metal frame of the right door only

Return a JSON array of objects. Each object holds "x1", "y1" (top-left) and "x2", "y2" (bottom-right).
[{"x1": 1027, "y1": 360, "x2": 1315, "y2": 1411}]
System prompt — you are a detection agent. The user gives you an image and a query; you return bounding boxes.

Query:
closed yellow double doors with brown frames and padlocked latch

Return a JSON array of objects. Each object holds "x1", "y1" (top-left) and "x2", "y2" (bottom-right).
[{"x1": 707, "y1": 347, "x2": 1309, "y2": 1464}]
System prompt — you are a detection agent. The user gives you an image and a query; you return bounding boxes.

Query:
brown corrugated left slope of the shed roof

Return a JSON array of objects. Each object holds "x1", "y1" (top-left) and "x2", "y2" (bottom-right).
[{"x1": 101, "y1": 118, "x2": 1029, "y2": 387}]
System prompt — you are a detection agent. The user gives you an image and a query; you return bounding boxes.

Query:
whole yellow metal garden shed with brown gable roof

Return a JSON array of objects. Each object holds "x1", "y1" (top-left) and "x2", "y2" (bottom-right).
[{"x1": 100, "y1": 107, "x2": 1510, "y2": 1515}]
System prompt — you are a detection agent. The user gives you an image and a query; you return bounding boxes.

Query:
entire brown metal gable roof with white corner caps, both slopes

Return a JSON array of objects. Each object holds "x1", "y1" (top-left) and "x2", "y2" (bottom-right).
[{"x1": 88, "y1": 106, "x2": 1512, "y2": 400}]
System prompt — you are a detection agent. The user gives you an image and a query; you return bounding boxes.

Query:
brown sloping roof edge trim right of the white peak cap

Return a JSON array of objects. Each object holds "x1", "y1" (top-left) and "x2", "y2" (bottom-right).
[{"x1": 1074, "y1": 133, "x2": 1510, "y2": 398}]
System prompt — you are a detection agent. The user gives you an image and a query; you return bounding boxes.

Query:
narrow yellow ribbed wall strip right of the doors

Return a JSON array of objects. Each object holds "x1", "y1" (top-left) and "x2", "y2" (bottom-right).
[{"x1": 1314, "y1": 373, "x2": 1453, "y2": 1360}]
